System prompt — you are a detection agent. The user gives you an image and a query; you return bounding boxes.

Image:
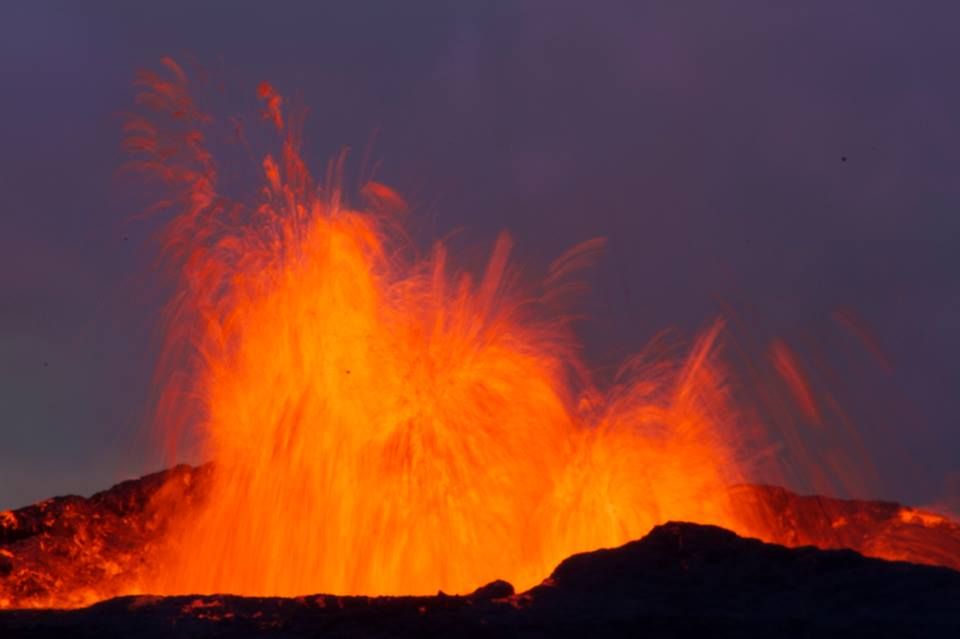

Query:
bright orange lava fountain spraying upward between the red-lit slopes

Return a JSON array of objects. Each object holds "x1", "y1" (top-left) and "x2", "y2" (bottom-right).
[{"x1": 128, "y1": 60, "x2": 742, "y2": 595}]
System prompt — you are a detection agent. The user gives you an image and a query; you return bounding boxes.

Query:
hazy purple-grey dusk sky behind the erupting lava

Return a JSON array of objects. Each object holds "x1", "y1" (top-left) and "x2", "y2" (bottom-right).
[{"x1": 0, "y1": 0, "x2": 960, "y2": 509}]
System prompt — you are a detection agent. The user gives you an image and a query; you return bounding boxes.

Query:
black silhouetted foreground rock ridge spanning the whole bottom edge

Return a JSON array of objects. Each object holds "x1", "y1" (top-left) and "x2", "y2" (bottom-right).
[{"x1": 0, "y1": 523, "x2": 960, "y2": 639}]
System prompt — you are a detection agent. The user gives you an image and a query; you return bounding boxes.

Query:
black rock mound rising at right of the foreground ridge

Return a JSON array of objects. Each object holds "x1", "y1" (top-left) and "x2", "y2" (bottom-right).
[{"x1": 531, "y1": 523, "x2": 960, "y2": 636}]
